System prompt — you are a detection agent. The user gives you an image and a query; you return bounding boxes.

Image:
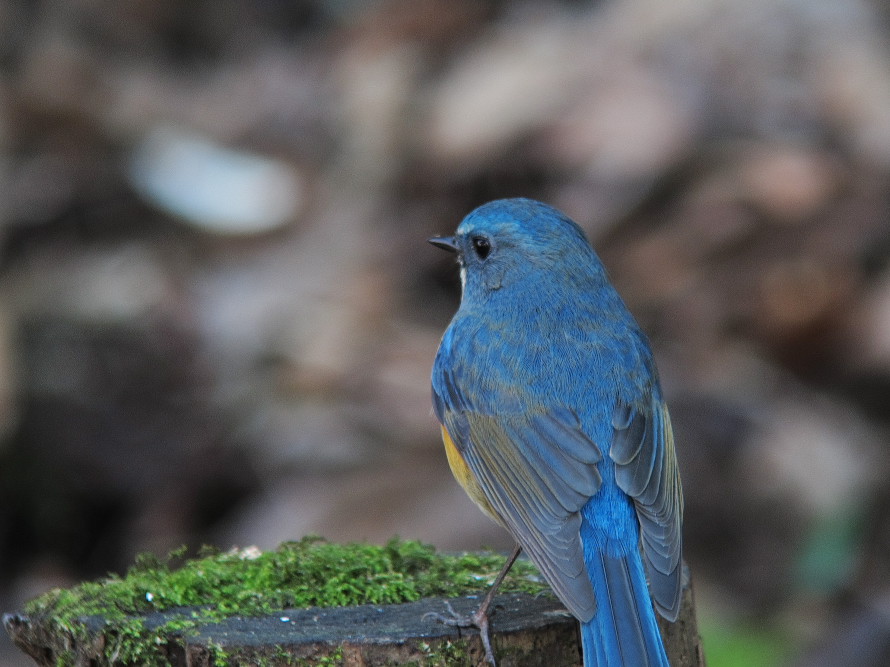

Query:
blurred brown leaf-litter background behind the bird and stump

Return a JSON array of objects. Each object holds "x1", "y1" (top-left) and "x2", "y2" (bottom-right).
[{"x1": 0, "y1": 0, "x2": 890, "y2": 667}]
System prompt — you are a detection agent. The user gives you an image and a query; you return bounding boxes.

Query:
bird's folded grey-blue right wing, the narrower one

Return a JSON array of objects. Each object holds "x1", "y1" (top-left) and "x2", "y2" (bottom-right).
[{"x1": 609, "y1": 396, "x2": 683, "y2": 621}]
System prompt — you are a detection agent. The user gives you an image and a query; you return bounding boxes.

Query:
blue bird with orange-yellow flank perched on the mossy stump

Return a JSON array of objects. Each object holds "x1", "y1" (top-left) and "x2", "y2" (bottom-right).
[{"x1": 429, "y1": 198, "x2": 684, "y2": 667}]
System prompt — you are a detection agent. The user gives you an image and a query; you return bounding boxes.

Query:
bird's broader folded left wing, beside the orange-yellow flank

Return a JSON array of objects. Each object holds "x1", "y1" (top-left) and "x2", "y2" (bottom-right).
[{"x1": 433, "y1": 374, "x2": 602, "y2": 621}]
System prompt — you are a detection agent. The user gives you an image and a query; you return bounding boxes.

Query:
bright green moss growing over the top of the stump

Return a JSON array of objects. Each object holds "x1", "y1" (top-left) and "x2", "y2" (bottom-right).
[{"x1": 26, "y1": 537, "x2": 547, "y2": 665}]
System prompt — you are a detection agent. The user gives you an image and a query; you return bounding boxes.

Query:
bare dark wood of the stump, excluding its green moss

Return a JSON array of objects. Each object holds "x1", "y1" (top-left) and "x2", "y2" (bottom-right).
[{"x1": 3, "y1": 587, "x2": 705, "y2": 667}]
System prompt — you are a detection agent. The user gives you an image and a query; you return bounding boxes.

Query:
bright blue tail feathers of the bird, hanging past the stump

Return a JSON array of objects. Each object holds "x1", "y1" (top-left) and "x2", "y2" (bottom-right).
[{"x1": 581, "y1": 552, "x2": 668, "y2": 667}]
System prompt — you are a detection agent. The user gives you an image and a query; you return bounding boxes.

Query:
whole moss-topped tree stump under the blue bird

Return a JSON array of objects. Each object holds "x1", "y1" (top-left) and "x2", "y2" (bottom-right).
[{"x1": 3, "y1": 541, "x2": 704, "y2": 667}]
